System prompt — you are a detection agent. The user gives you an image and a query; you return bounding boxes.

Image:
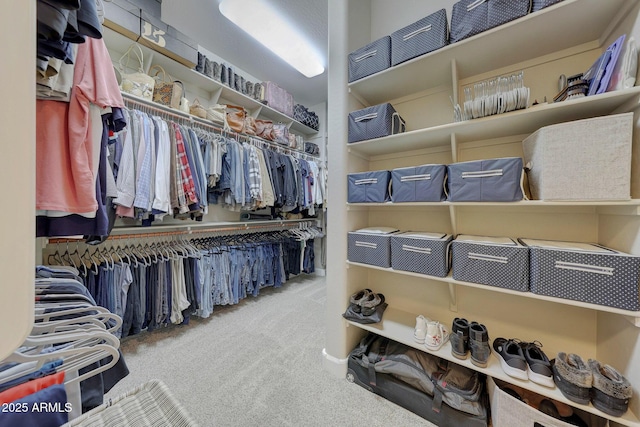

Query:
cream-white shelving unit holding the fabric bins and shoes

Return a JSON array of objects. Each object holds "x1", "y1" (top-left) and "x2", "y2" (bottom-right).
[{"x1": 325, "y1": 0, "x2": 640, "y2": 427}]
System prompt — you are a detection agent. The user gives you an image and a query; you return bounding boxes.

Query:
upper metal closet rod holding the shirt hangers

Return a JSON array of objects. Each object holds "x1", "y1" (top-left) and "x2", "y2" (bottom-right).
[{"x1": 122, "y1": 92, "x2": 322, "y2": 162}]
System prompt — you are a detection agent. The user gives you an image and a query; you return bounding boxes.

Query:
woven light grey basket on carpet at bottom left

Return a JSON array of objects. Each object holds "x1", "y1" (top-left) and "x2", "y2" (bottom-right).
[{"x1": 63, "y1": 380, "x2": 198, "y2": 427}]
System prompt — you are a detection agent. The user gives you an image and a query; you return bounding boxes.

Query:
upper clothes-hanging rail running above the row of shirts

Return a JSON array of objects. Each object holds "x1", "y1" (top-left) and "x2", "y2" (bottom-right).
[{"x1": 122, "y1": 92, "x2": 322, "y2": 162}]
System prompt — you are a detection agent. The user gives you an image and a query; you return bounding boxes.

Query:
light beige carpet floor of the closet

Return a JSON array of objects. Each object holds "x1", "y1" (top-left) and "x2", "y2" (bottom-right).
[{"x1": 106, "y1": 275, "x2": 433, "y2": 427}]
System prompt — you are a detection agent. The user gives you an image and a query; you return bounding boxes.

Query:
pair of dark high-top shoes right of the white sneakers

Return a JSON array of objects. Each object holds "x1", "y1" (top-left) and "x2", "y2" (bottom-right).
[{"x1": 449, "y1": 317, "x2": 491, "y2": 368}]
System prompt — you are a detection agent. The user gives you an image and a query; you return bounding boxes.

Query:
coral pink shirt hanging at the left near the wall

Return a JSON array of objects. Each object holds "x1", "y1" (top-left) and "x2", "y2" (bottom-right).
[{"x1": 36, "y1": 37, "x2": 124, "y2": 213}]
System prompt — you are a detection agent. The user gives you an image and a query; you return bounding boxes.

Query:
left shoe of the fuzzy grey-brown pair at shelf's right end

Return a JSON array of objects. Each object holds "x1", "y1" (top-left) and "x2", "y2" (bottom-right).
[{"x1": 552, "y1": 352, "x2": 593, "y2": 405}]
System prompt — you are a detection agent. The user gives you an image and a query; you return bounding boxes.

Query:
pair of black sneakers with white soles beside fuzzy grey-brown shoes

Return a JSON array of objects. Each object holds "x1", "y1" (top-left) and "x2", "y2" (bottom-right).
[{"x1": 493, "y1": 338, "x2": 555, "y2": 388}]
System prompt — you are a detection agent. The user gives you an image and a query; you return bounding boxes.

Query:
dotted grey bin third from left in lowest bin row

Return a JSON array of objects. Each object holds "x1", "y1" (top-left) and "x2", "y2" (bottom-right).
[{"x1": 451, "y1": 235, "x2": 529, "y2": 292}]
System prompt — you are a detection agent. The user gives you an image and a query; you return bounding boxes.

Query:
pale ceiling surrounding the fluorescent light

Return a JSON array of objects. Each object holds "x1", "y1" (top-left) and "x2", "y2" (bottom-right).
[{"x1": 162, "y1": 0, "x2": 328, "y2": 107}]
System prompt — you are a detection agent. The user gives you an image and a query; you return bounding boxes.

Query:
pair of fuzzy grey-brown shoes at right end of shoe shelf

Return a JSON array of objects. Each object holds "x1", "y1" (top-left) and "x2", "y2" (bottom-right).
[{"x1": 553, "y1": 352, "x2": 633, "y2": 417}]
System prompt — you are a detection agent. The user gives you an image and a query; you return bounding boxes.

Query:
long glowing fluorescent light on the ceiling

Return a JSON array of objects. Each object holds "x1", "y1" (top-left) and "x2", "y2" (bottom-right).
[{"x1": 219, "y1": 0, "x2": 324, "y2": 77}]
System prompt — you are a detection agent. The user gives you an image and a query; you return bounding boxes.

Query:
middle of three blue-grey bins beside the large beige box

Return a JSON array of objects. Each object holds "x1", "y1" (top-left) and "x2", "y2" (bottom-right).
[{"x1": 391, "y1": 165, "x2": 447, "y2": 203}]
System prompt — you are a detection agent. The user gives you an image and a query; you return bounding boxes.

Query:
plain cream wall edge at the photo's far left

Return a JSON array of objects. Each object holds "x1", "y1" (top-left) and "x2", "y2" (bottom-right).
[{"x1": 0, "y1": 0, "x2": 36, "y2": 359}]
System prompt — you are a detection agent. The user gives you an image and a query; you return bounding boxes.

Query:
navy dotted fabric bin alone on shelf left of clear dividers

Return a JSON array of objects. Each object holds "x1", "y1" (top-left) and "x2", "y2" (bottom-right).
[{"x1": 348, "y1": 102, "x2": 405, "y2": 142}]
